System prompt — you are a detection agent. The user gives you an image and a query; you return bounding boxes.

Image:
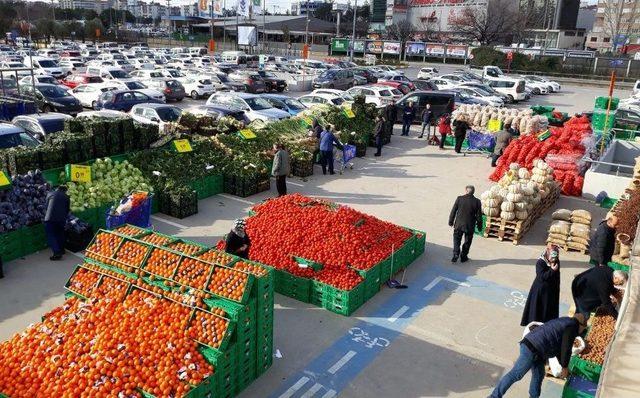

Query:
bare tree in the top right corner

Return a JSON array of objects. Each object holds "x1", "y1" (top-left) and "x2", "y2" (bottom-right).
[{"x1": 601, "y1": 0, "x2": 640, "y2": 51}]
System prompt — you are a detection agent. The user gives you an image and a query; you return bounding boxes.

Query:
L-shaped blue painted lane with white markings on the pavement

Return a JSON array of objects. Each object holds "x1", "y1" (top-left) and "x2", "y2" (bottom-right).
[{"x1": 270, "y1": 266, "x2": 568, "y2": 398}]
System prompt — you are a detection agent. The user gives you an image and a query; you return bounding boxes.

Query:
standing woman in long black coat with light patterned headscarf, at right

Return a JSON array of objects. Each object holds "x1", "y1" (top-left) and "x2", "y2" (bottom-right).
[{"x1": 520, "y1": 245, "x2": 560, "y2": 326}]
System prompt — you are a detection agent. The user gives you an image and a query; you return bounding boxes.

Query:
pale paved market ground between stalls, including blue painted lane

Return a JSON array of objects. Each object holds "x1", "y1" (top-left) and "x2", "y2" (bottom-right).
[{"x1": 0, "y1": 105, "x2": 604, "y2": 398}]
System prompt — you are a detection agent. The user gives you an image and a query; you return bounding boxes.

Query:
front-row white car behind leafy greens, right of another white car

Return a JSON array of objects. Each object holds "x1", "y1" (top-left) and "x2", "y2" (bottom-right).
[{"x1": 207, "y1": 93, "x2": 289, "y2": 122}]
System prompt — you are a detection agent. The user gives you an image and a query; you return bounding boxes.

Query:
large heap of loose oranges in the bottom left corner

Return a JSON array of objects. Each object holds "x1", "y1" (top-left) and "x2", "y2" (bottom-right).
[{"x1": 0, "y1": 290, "x2": 215, "y2": 398}]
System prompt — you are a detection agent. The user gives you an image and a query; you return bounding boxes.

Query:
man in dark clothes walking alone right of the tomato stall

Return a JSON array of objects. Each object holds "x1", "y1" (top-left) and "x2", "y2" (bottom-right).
[{"x1": 449, "y1": 185, "x2": 482, "y2": 263}]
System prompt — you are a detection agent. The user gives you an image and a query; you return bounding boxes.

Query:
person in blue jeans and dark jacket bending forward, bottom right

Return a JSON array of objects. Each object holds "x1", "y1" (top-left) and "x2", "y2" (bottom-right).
[{"x1": 489, "y1": 314, "x2": 587, "y2": 398}]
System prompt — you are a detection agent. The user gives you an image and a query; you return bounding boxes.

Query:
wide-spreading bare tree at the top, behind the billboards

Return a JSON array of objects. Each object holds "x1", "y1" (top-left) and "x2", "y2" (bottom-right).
[{"x1": 450, "y1": 0, "x2": 520, "y2": 45}]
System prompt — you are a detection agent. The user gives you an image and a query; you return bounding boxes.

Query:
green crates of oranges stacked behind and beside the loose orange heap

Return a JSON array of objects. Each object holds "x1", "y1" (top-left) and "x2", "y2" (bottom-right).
[{"x1": 0, "y1": 225, "x2": 274, "y2": 398}]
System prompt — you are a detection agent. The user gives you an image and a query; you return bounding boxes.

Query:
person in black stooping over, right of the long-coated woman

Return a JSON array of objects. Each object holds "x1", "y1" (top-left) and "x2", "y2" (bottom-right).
[{"x1": 571, "y1": 265, "x2": 627, "y2": 319}]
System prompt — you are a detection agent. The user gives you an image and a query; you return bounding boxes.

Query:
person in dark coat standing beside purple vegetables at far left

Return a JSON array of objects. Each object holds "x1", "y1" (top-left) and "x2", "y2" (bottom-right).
[{"x1": 44, "y1": 185, "x2": 71, "y2": 261}]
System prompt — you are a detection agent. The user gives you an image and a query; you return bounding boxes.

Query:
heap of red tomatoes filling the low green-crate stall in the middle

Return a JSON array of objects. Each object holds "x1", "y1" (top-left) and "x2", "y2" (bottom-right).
[{"x1": 247, "y1": 194, "x2": 411, "y2": 288}]
